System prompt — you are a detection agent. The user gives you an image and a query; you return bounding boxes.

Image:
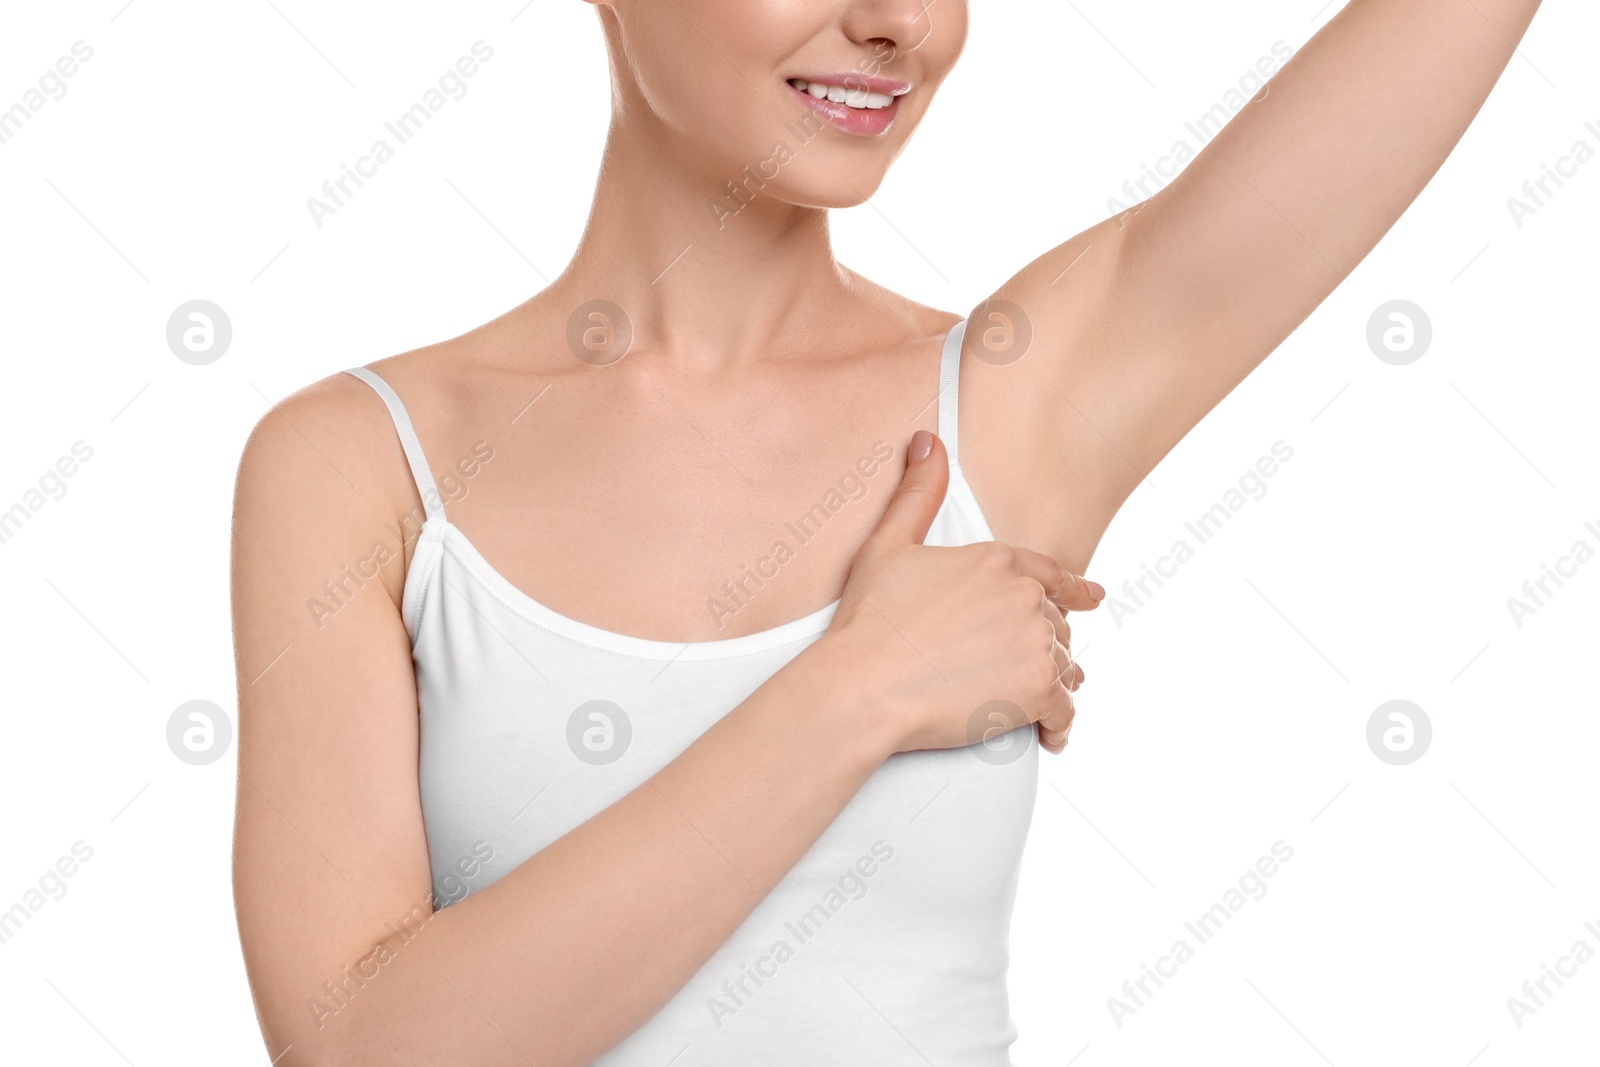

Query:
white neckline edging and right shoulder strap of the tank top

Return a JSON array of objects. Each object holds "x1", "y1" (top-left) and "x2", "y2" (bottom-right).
[{"x1": 390, "y1": 318, "x2": 994, "y2": 661}]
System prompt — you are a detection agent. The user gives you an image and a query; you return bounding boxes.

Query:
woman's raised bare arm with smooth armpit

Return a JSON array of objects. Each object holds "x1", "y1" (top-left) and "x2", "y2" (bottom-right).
[{"x1": 953, "y1": 0, "x2": 1539, "y2": 565}]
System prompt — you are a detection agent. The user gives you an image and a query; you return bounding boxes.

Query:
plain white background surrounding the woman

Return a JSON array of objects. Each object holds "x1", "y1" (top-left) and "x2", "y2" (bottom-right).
[{"x1": 0, "y1": 0, "x2": 1600, "y2": 1067}]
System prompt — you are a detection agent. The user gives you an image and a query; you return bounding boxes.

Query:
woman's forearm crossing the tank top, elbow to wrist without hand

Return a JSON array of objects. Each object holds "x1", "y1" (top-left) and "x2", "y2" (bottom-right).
[{"x1": 264, "y1": 633, "x2": 898, "y2": 1067}]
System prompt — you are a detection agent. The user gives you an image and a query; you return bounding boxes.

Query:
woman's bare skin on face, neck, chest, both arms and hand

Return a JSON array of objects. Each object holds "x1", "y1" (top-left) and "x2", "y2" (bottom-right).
[{"x1": 234, "y1": 0, "x2": 1538, "y2": 1064}]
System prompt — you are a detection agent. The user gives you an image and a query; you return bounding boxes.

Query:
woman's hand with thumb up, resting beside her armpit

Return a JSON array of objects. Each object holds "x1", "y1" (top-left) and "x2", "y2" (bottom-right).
[{"x1": 827, "y1": 430, "x2": 1106, "y2": 752}]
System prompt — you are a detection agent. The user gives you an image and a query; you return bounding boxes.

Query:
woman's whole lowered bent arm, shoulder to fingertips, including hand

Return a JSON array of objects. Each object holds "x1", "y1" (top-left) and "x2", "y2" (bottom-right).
[{"x1": 234, "y1": 403, "x2": 1096, "y2": 1067}]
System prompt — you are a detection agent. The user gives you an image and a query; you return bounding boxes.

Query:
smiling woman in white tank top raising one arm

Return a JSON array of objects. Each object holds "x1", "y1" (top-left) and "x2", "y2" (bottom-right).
[{"x1": 234, "y1": 0, "x2": 1538, "y2": 1067}]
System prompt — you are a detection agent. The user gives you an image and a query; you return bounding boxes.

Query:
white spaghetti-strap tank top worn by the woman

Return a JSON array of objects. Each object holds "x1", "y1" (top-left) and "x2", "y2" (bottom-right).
[{"x1": 347, "y1": 322, "x2": 1038, "y2": 1067}]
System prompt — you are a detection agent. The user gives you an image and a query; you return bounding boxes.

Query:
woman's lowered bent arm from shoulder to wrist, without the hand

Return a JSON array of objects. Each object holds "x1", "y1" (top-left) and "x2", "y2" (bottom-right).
[{"x1": 234, "y1": 376, "x2": 894, "y2": 1067}]
